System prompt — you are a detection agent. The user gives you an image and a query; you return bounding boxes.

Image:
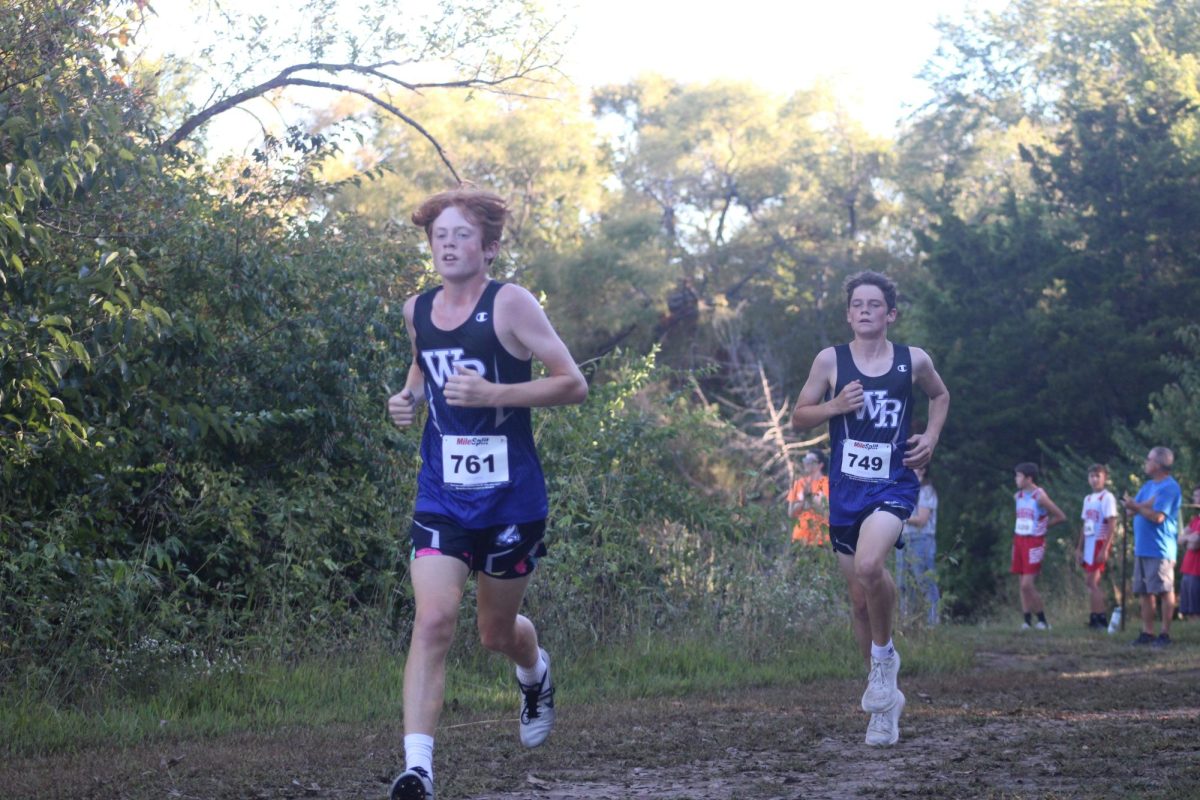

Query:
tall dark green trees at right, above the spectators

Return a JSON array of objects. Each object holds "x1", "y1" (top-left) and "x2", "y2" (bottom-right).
[{"x1": 906, "y1": 1, "x2": 1200, "y2": 612}]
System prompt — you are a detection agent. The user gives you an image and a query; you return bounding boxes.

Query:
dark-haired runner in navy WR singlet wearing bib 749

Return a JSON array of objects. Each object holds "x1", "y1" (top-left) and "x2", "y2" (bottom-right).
[{"x1": 792, "y1": 272, "x2": 950, "y2": 746}]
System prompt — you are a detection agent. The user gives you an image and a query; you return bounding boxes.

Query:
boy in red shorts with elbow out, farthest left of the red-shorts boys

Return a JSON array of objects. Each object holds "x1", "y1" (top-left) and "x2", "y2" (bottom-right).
[{"x1": 1012, "y1": 462, "x2": 1067, "y2": 631}]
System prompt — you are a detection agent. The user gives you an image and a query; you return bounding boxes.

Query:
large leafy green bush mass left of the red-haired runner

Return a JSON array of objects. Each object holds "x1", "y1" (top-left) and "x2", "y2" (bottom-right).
[{"x1": 0, "y1": 4, "x2": 432, "y2": 690}]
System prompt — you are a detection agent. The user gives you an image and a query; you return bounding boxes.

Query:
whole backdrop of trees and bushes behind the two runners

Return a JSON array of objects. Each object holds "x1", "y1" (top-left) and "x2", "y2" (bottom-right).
[{"x1": 7, "y1": 0, "x2": 1200, "y2": 724}]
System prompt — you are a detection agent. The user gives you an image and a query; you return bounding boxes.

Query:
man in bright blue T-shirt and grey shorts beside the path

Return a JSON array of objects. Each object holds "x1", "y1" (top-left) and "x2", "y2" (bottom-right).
[{"x1": 1124, "y1": 447, "x2": 1183, "y2": 648}]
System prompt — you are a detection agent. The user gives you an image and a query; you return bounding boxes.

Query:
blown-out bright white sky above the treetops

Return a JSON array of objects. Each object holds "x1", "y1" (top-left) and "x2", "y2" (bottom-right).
[{"x1": 149, "y1": 0, "x2": 1004, "y2": 151}]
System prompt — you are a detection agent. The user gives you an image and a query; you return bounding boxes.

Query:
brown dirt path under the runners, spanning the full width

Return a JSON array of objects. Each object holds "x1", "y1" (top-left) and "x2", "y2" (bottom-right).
[{"x1": 0, "y1": 634, "x2": 1200, "y2": 800}]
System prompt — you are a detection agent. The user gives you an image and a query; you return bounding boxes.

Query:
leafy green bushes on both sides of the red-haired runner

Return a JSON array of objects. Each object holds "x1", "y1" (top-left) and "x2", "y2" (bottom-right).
[{"x1": 0, "y1": 0, "x2": 844, "y2": 698}]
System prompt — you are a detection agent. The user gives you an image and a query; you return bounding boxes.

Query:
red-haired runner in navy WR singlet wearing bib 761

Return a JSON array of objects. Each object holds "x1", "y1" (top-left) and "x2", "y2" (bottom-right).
[{"x1": 388, "y1": 188, "x2": 588, "y2": 800}]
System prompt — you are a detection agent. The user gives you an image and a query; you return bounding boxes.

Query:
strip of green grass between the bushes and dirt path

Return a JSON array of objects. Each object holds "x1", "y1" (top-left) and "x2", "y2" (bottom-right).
[{"x1": 0, "y1": 619, "x2": 971, "y2": 756}]
